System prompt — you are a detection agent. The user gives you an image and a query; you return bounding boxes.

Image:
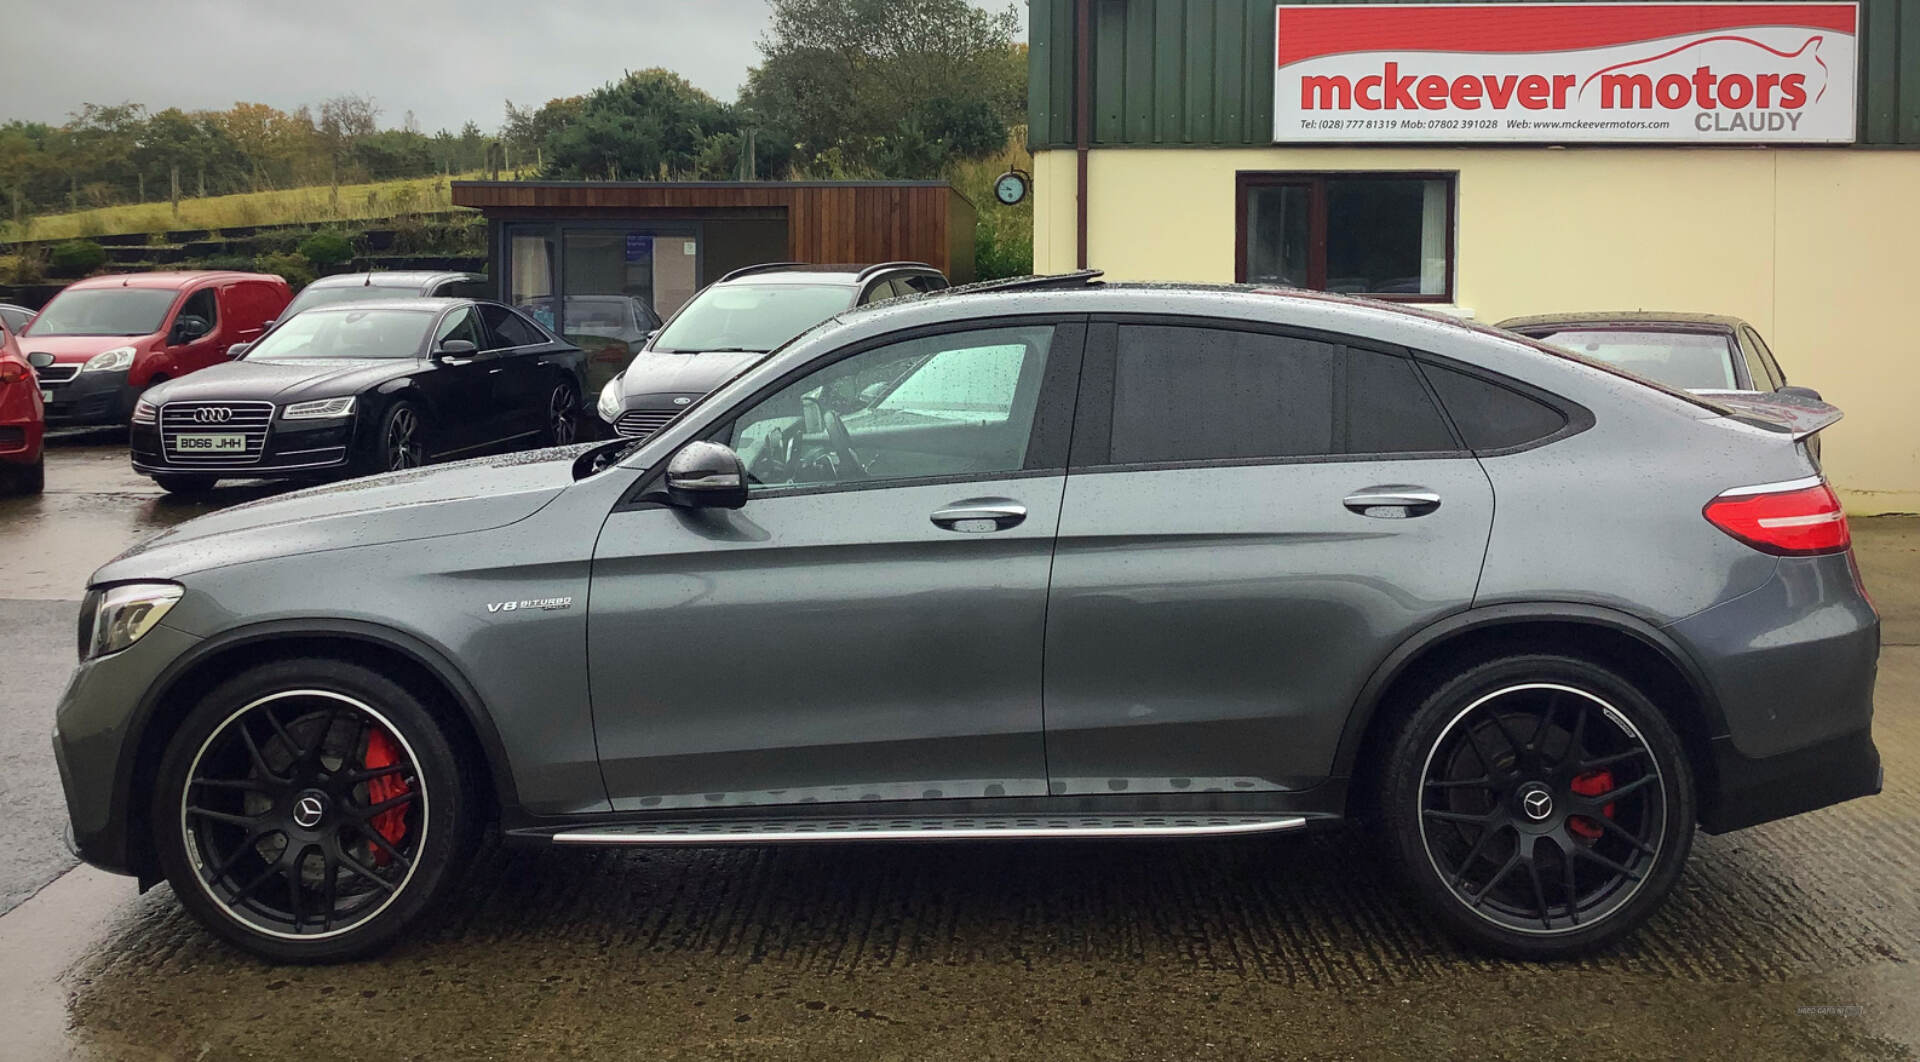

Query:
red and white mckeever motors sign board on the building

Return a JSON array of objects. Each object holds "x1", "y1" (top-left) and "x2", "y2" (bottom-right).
[{"x1": 1273, "y1": 4, "x2": 1860, "y2": 144}]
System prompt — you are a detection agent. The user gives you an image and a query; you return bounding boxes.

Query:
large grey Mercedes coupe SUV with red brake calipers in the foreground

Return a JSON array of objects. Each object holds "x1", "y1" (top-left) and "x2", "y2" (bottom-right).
[{"x1": 54, "y1": 277, "x2": 1880, "y2": 960}]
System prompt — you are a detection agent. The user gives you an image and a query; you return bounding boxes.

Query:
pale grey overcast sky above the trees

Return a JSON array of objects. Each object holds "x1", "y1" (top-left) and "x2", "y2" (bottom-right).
[{"x1": 0, "y1": 0, "x2": 1025, "y2": 133}]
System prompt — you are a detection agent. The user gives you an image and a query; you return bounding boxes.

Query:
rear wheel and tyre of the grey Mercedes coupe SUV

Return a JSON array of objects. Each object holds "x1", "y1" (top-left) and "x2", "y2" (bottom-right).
[{"x1": 1380, "y1": 655, "x2": 1695, "y2": 960}]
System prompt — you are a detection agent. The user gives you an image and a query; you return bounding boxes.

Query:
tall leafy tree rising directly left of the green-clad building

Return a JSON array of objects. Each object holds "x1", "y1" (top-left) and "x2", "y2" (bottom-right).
[{"x1": 741, "y1": 0, "x2": 1027, "y2": 177}]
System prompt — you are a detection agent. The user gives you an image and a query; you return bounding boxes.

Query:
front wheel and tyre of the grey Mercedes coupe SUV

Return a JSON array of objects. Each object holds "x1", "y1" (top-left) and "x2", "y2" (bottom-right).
[{"x1": 152, "y1": 659, "x2": 478, "y2": 962}]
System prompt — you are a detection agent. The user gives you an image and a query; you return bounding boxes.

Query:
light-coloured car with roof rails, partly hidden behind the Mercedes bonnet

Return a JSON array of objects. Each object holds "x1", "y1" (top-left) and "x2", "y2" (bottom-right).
[{"x1": 599, "y1": 261, "x2": 947, "y2": 438}]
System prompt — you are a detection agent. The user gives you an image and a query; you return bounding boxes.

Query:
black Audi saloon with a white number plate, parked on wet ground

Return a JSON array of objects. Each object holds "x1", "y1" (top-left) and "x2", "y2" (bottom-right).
[{"x1": 132, "y1": 298, "x2": 586, "y2": 494}]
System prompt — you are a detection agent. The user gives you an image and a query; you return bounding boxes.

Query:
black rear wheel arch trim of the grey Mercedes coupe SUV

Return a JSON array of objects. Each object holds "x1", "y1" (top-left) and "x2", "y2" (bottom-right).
[{"x1": 1332, "y1": 603, "x2": 1726, "y2": 814}]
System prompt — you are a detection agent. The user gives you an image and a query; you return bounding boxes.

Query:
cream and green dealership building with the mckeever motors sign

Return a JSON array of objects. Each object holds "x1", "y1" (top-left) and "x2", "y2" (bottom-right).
[{"x1": 1029, "y1": 0, "x2": 1920, "y2": 513}]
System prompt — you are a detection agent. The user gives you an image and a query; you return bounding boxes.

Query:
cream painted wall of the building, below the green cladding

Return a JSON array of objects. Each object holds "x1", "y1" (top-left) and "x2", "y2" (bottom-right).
[{"x1": 1033, "y1": 148, "x2": 1920, "y2": 513}]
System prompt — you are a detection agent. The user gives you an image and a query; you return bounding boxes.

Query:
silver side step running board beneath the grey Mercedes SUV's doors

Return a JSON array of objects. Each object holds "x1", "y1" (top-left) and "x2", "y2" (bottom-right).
[{"x1": 553, "y1": 814, "x2": 1308, "y2": 845}]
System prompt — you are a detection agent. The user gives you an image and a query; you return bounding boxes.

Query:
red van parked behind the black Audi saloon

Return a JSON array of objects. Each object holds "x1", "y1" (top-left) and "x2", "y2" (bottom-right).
[{"x1": 19, "y1": 273, "x2": 294, "y2": 426}]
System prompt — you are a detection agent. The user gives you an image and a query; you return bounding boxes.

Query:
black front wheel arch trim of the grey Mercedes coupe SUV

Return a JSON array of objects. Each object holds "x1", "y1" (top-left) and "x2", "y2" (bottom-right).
[{"x1": 113, "y1": 620, "x2": 518, "y2": 887}]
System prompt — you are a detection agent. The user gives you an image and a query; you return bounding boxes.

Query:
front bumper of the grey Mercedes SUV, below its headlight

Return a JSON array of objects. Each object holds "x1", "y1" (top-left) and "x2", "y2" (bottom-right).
[{"x1": 54, "y1": 624, "x2": 200, "y2": 874}]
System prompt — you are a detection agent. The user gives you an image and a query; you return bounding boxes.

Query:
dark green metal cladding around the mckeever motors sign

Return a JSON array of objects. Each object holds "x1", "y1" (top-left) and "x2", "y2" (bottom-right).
[{"x1": 1027, "y1": 0, "x2": 1920, "y2": 150}]
